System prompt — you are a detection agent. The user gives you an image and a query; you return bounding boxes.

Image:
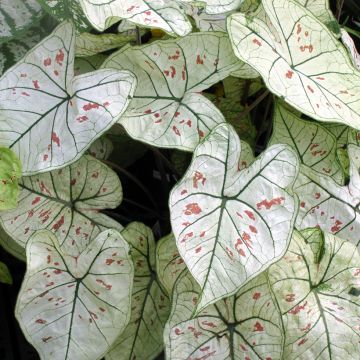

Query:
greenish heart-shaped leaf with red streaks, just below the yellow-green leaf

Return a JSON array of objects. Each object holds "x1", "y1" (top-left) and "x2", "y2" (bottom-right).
[{"x1": 0, "y1": 155, "x2": 122, "y2": 258}]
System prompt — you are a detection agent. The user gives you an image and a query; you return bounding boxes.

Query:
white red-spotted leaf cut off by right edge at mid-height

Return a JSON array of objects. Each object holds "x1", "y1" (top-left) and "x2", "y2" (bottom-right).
[{"x1": 294, "y1": 144, "x2": 360, "y2": 246}]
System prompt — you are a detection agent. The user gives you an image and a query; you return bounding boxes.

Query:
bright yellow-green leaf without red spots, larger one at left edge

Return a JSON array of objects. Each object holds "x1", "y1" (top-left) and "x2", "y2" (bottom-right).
[{"x1": 0, "y1": 146, "x2": 21, "y2": 210}]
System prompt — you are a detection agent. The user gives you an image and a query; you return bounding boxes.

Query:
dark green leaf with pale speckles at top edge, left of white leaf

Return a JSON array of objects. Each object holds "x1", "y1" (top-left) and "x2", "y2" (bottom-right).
[{"x1": 38, "y1": 0, "x2": 91, "y2": 31}]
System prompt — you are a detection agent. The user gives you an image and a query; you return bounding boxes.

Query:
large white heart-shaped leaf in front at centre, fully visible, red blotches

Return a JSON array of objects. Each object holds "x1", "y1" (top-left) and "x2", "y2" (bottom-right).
[{"x1": 170, "y1": 124, "x2": 299, "y2": 310}]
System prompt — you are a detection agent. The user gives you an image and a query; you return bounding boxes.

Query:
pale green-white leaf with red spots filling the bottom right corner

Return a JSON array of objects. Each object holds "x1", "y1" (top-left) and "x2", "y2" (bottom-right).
[{"x1": 269, "y1": 229, "x2": 360, "y2": 360}]
